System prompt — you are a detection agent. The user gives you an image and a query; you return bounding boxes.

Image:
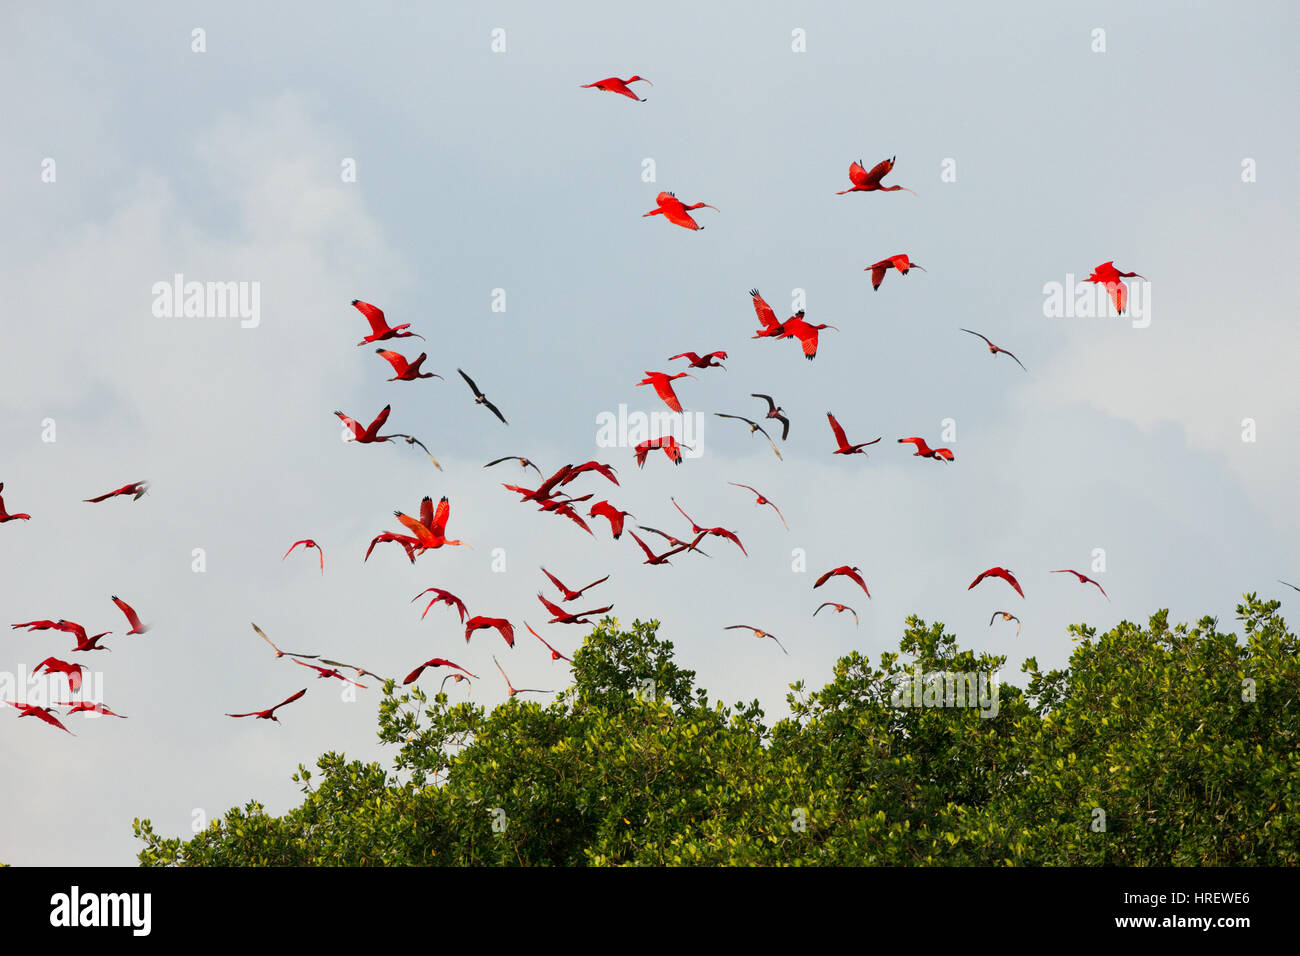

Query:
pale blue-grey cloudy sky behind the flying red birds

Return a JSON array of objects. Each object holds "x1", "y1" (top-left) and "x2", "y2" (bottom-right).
[{"x1": 0, "y1": 3, "x2": 1300, "y2": 865}]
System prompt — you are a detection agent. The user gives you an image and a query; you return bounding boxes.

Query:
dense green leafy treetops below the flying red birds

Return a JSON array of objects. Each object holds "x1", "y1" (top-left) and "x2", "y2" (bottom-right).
[{"x1": 135, "y1": 594, "x2": 1300, "y2": 866}]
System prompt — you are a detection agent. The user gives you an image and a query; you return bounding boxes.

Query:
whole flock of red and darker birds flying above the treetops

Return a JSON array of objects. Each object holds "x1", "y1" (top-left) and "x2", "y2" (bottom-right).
[{"x1": 0, "y1": 75, "x2": 1159, "y2": 734}]
